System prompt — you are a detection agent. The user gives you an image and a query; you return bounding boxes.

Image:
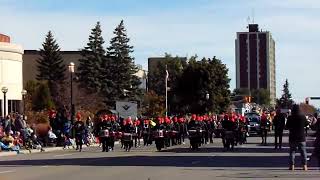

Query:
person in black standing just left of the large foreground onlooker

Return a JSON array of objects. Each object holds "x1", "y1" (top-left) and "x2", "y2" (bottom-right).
[{"x1": 273, "y1": 109, "x2": 286, "y2": 149}]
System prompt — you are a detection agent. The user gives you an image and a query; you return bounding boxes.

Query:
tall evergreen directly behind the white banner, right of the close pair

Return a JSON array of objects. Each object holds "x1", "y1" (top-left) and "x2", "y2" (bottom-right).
[{"x1": 102, "y1": 20, "x2": 141, "y2": 105}]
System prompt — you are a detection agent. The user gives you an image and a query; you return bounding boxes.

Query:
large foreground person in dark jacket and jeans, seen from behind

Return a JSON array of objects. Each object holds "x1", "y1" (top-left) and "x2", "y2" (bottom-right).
[{"x1": 286, "y1": 104, "x2": 308, "y2": 170}]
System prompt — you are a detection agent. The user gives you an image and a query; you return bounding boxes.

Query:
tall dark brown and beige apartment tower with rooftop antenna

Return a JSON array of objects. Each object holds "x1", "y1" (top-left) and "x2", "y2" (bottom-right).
[{"x1": 235, "y1": 24, "x2": 276, "y2": 105}]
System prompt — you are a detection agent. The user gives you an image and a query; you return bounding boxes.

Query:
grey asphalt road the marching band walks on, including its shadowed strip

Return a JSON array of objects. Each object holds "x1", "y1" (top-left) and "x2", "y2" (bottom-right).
[{"x1": 0, "y1": 134, "x2": 320, "y2": 180}]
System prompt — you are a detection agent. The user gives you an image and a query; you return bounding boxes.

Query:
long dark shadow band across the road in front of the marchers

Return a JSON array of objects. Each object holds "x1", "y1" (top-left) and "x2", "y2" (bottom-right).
[{"x1": 0, "y1": 154, "x2": 316, "y2": 168}]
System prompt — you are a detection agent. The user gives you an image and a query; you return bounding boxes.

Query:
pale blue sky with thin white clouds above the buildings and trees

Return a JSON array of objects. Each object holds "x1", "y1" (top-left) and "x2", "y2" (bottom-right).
[{"x1": 0, "y1": 0, "x2": 320, "y2": 105}]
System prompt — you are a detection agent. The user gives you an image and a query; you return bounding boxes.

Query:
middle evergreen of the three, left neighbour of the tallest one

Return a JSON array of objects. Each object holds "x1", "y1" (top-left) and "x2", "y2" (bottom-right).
[{"x1": 77, "y1": 22, "x2": 106, "y2": 92}]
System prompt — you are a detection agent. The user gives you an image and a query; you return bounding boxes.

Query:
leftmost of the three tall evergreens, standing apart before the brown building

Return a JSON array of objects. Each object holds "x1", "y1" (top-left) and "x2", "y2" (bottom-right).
[{"x1": 37, "y1": 31, "x2": 66, "y2": 103}]
